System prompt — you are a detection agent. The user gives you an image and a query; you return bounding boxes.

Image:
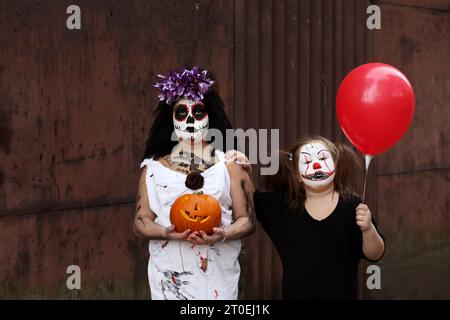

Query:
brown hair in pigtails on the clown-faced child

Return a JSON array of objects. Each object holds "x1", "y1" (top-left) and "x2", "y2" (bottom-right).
[{"x1": 266, "y1": 136, "x2": 363, "y2": 211}]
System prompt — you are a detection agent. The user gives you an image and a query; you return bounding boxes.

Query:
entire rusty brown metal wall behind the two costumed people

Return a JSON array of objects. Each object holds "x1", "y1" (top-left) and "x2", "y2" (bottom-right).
[{"x1": 0, "y1": 0, "x2": 450, "y2": 299}]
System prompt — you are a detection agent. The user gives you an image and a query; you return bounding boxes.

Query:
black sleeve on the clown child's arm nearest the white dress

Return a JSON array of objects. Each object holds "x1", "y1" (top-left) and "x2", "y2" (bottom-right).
[{"x1": 253, "y1": 191, "x2": 286, "y2": 251}]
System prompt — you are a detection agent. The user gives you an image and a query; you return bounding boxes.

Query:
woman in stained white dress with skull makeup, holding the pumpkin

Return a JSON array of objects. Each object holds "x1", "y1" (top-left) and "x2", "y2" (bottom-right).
[{"x1": 133, "y1": 68, "x2": 255, "y2": 300}]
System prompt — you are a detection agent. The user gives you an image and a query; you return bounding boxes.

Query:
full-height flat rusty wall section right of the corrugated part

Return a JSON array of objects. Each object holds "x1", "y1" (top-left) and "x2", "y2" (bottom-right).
[{"x1": 368, "y1": 0, "x2": 450, "y2": 299}]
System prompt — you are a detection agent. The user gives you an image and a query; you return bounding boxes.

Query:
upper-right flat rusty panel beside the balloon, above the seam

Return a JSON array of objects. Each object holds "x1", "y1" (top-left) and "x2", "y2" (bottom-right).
[{"x1": 374, "y1": 5, "x2": 450, "y2": 174}]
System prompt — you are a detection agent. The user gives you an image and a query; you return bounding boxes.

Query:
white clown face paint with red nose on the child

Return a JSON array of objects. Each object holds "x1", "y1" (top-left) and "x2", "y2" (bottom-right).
[{"x1": 298, "y1": 142, "x2": 334, "y2": 189}]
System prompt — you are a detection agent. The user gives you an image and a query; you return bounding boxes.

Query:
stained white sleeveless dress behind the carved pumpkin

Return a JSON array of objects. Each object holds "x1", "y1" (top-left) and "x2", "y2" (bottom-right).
[{"x1": 141, "y1": 150, "x2": 241, "y2": 300}]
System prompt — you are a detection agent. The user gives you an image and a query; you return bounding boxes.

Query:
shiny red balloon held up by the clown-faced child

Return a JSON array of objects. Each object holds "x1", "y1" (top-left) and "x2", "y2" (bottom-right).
[{"x1": 336, "y1": 63, "x2": 415, "y2": 155}]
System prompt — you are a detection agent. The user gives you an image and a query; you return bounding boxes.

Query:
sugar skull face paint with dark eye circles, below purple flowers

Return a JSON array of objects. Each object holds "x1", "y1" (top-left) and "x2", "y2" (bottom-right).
[{"x1": 173, "y1": 99, "x2": 209, "y2": 143}]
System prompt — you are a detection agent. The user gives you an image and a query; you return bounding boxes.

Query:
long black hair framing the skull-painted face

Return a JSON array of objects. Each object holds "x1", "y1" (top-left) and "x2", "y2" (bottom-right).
[{"x1": 143, "y1": 73, "x2": 236, "y2": 160}]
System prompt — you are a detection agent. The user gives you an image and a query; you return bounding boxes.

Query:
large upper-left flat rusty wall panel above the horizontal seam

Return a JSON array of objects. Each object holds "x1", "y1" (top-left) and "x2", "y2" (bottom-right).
[{"x1": 0, "y1": 1, "x2": 236, "y2": 218}]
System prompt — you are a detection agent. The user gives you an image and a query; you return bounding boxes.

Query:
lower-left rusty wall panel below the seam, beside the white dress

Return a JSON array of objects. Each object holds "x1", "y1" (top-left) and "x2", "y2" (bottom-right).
[{"x1": 0, "y1": 205, "x2": 149, "y2": 299}]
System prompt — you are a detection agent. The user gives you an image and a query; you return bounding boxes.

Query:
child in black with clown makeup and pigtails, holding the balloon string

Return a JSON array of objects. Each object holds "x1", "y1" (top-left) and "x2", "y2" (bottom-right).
[{"x1": 230, "y1": 136, "x2": 384, "y2": 299}]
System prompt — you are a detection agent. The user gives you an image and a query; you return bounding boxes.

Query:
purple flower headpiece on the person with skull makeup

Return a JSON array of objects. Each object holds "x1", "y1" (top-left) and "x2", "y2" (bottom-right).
[{"x1": 155, "y1": 67, "x2": 214, "y2": 104}]
